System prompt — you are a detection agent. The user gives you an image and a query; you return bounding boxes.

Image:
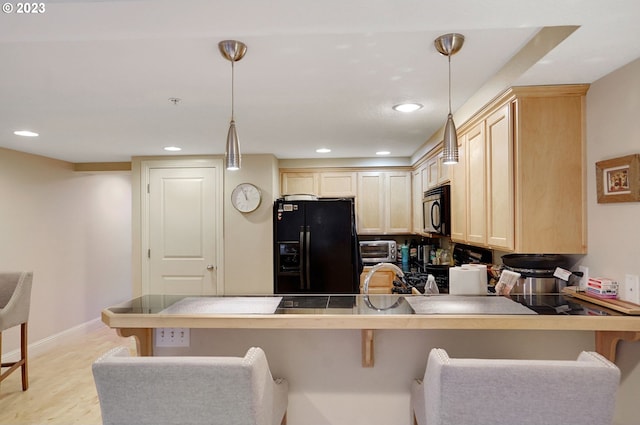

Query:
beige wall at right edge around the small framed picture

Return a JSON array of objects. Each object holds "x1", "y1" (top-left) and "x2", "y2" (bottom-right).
[{"x1": 581, "y1": 59, "x2": 640, "y2": 424}]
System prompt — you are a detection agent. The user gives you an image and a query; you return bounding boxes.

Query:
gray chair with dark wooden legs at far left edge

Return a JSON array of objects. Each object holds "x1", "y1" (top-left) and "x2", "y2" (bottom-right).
[{"x1": 0, "y1": 272, "x2": 33, "y2": 391}]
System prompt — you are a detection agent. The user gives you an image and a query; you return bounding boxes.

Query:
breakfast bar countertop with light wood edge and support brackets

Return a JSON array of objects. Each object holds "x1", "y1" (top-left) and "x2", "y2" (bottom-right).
[{"x1": 102, "y1": 294, "x2": 640, "y2": 367}]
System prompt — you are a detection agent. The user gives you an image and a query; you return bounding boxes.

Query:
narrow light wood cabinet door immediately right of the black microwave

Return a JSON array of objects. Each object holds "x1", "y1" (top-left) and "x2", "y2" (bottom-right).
[{"x1": 450, "y1": 137, "x2": 467, "y2": 243}]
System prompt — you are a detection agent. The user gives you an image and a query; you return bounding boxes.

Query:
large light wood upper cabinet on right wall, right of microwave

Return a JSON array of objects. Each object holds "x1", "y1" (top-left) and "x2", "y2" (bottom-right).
[{"x1": 451, "y1": 84, "x2": 589, "y2": 254}]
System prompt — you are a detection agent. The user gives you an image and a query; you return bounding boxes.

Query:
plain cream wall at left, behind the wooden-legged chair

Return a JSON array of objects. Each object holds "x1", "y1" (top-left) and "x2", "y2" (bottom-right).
[{"x1": 0, "y1": 149, "x2": 131, "y2": 353}]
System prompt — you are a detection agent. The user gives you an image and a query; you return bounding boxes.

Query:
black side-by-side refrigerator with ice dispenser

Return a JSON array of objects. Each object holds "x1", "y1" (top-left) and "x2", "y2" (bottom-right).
[{"x1": 273, "y1": 198, "x2": 362, "y2": 294}]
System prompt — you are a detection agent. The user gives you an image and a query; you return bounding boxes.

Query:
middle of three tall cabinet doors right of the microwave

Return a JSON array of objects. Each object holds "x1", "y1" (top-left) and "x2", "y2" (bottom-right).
[{"x1": 465, "y1": 122, "x2": 487, "y2": 244}]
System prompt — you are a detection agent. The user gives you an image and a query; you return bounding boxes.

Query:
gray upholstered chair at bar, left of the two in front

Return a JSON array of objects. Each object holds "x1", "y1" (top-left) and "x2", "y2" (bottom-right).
[{"x1": 93, "y1": 347, "x2": 288, "y2": 425}]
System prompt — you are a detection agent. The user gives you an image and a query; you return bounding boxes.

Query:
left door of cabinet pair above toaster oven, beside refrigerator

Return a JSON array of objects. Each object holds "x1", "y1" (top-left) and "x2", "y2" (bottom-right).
[{"x1": 356, "y1": 172, "x2": 385, "y2": 234}]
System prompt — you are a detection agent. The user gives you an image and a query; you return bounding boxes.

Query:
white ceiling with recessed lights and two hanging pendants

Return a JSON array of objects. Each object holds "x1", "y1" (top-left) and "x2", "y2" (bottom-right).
[{"x1": 0, "y1": 0, "x2": 640, "y2": 163}]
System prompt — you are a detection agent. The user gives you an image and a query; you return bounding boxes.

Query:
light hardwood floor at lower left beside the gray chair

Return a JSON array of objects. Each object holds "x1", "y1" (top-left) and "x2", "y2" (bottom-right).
[{"x1": 0, "y1": 326, "x2": 135, "y2": 425}]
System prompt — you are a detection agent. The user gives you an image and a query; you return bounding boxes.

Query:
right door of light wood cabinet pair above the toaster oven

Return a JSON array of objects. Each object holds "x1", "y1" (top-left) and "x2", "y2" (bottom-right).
[{"x1": 385, "y1": 171, "x2": 411, "y2": 233}]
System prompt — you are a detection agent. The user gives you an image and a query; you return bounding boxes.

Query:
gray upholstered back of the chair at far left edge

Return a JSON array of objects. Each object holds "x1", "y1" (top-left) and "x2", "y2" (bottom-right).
[{"x1": 0, "y1": 272, "x2": 33, "y2": 332}]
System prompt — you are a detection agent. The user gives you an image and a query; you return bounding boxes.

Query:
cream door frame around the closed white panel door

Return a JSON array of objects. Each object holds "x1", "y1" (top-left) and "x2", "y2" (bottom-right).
[{"x1": 131, "y1": 156, "x2": 224, "y2": 296}]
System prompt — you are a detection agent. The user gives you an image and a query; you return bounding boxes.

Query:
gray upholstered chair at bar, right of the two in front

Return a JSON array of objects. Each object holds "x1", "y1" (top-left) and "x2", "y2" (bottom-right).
[{"x1": 411, "y1": 348, "x2": 620, "y2": 425}]
